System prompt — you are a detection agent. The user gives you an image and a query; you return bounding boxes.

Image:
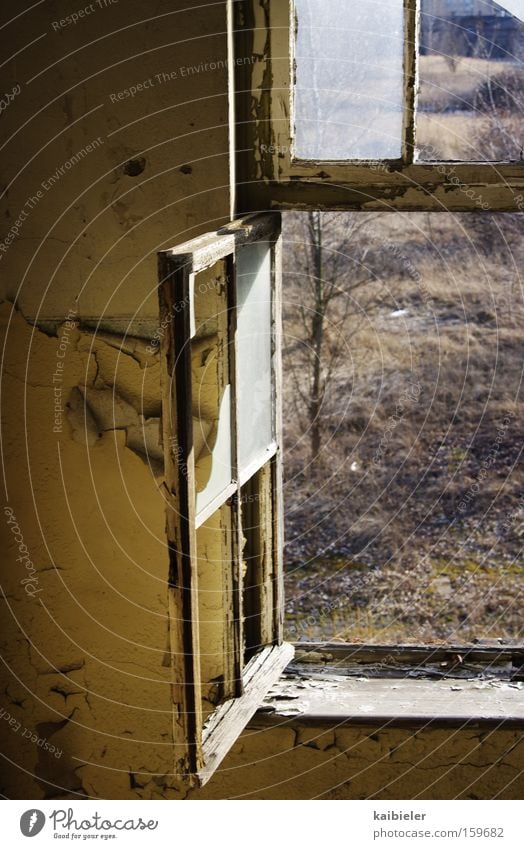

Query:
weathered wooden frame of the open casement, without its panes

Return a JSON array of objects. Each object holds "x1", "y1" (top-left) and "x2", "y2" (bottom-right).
[{"x1": 159, "y1": 213, "x2": 294, "y2": 785}]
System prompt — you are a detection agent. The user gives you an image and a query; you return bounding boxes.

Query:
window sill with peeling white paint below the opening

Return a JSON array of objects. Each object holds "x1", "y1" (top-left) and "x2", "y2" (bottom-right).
[{"x1": 251, "y1": 644, "x2": 524, "y2": 728}]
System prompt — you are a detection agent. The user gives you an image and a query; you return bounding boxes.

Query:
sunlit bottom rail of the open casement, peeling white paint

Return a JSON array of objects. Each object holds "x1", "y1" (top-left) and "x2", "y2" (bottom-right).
[{"x1": 198, "y1": 643, "x2": 294, "y2": 784}]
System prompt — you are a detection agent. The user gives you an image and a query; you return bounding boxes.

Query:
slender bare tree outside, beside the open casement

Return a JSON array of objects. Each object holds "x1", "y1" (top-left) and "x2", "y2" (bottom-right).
[{"x1": 285, "y1": 210, "x2": 385, "y2": 463}]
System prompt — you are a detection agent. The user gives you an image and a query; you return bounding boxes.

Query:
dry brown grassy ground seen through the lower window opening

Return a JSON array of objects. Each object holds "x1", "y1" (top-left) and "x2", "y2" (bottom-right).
[{"x1": 285, "y1": 214, "x2": 524, "y2": 642}]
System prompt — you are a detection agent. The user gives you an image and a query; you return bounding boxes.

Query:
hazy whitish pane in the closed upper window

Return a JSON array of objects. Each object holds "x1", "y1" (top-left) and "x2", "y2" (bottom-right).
[{"x1": 295, "y1": 0, "x2": 404, "y2": 159}]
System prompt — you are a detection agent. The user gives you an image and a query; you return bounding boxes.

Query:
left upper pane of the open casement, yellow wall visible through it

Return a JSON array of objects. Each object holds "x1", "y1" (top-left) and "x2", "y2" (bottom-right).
[{"x1": 191, "y1": 261, "x2": 233, "y2": 514}]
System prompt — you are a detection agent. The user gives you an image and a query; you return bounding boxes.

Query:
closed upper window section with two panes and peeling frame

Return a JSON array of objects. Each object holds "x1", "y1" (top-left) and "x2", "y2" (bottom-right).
[{"x1": 234, "y1": 0, "x2": 524, "y2": 211}]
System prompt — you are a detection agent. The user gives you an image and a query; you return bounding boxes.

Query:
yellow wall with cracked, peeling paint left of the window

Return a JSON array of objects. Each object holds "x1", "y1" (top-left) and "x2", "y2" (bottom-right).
[{"x1": 0, "y1": 0, "x2": 231, "y2": 798}]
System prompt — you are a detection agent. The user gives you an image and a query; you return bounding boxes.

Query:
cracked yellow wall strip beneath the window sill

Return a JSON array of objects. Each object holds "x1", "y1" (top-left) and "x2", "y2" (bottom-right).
[{"x1": 191, "y1": 719, "x2": 523, "y2": 799}]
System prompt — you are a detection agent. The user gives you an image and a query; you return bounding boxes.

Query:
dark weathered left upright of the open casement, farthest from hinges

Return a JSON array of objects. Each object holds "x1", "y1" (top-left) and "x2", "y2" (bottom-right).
[{"x1": 160, "y1": 255, "x2": 202, "y2": 774}]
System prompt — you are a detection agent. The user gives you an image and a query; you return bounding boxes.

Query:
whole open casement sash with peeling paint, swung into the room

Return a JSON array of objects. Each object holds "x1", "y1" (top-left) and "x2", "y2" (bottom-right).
[{"x1": 160, "y1": 214, "x2": 293, "y2": 783}]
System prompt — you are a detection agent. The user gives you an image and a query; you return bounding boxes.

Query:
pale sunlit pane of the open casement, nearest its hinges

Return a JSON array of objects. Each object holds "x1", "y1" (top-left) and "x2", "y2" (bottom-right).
[{"x1": 236, "y1": 244, "x2": 273, "y2": 472}]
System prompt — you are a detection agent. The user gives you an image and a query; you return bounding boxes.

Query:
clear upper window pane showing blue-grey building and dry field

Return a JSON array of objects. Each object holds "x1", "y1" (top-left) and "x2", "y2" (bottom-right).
[{"x1": 417, "y1": 0, "x2": 524, "y2": 161}]
